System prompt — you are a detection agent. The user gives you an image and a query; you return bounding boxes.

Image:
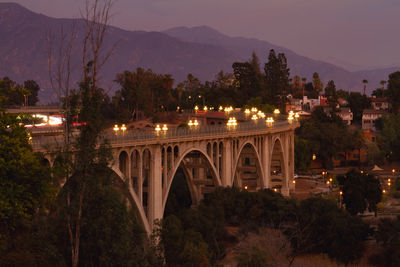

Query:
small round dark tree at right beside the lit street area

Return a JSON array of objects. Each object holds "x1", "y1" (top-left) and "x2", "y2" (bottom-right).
[{"x1": 338, "y1": 169, "x2": 382, "y2": 216}]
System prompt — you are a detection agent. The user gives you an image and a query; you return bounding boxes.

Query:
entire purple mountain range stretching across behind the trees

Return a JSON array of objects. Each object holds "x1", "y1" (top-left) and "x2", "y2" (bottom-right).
[{"x1": 0, "y1": 3, "x2": 400, "y2": 103}]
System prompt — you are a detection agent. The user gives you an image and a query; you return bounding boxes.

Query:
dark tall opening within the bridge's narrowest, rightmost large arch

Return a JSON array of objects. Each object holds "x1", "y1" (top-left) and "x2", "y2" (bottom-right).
[{"x1": 269, "y1": 139, "x2": 286, "y2": 192}]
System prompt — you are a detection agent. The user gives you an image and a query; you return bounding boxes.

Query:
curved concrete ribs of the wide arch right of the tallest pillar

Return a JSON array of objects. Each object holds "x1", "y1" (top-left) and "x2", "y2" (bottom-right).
[{"x1": 162, "y1": 148, "x2": 221, "y2": 214}]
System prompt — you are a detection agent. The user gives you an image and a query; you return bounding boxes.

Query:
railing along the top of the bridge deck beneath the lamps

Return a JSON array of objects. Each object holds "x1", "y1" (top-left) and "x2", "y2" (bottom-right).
[{"x1": 32, "y1": 119, "x2": 297, "y2": 150}]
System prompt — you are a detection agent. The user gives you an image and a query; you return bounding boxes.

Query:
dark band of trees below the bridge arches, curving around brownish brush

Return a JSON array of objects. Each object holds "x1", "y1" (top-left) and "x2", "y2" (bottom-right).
[{"x1": 161, "y1": 188, "x2": 372, "y2": 266}]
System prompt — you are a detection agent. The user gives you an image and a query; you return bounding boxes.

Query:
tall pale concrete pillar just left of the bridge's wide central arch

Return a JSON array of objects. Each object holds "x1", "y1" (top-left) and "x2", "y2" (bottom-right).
[{"x1": 148, "y1": 146, "x2": 163, "y2": 228}]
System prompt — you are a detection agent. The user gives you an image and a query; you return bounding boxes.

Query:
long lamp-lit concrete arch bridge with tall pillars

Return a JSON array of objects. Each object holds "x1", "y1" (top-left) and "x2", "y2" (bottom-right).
[{"x1": 32, "y1": 119, "x2": 298, "y2": 234}]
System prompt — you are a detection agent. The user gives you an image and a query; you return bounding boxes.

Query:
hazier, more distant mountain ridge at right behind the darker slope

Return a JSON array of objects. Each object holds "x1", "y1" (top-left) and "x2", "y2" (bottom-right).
[{"x1": 163, "y1": 26, "x2": 400, "y2": 93}]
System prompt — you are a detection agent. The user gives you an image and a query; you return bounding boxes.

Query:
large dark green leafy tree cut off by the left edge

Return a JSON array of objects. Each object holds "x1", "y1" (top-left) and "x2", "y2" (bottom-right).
[{"x1": 0, "y1": 110, "x2": 55, "y2": 260}]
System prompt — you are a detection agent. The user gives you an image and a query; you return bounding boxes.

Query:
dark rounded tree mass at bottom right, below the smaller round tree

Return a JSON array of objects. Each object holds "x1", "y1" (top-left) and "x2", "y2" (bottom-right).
[{"x1": 285, "y1": 198, "x2": 370, "y2": 264}]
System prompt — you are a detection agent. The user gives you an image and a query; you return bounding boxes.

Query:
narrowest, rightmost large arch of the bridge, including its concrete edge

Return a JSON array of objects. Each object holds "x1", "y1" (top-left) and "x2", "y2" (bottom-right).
[{"x1": 269, "y1": 137, "x2": 287, "y2": 192}]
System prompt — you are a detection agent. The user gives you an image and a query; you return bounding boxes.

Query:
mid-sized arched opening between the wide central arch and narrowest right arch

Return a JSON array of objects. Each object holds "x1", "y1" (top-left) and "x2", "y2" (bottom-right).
[{"x1": 233, "y1": 143, "x2": 263, "y2": 192}]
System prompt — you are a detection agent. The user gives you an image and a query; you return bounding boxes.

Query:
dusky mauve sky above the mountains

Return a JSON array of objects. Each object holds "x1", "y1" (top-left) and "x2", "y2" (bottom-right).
[{"x1": 0, "y1": 0, "x2": 400, "y2": 70}]
